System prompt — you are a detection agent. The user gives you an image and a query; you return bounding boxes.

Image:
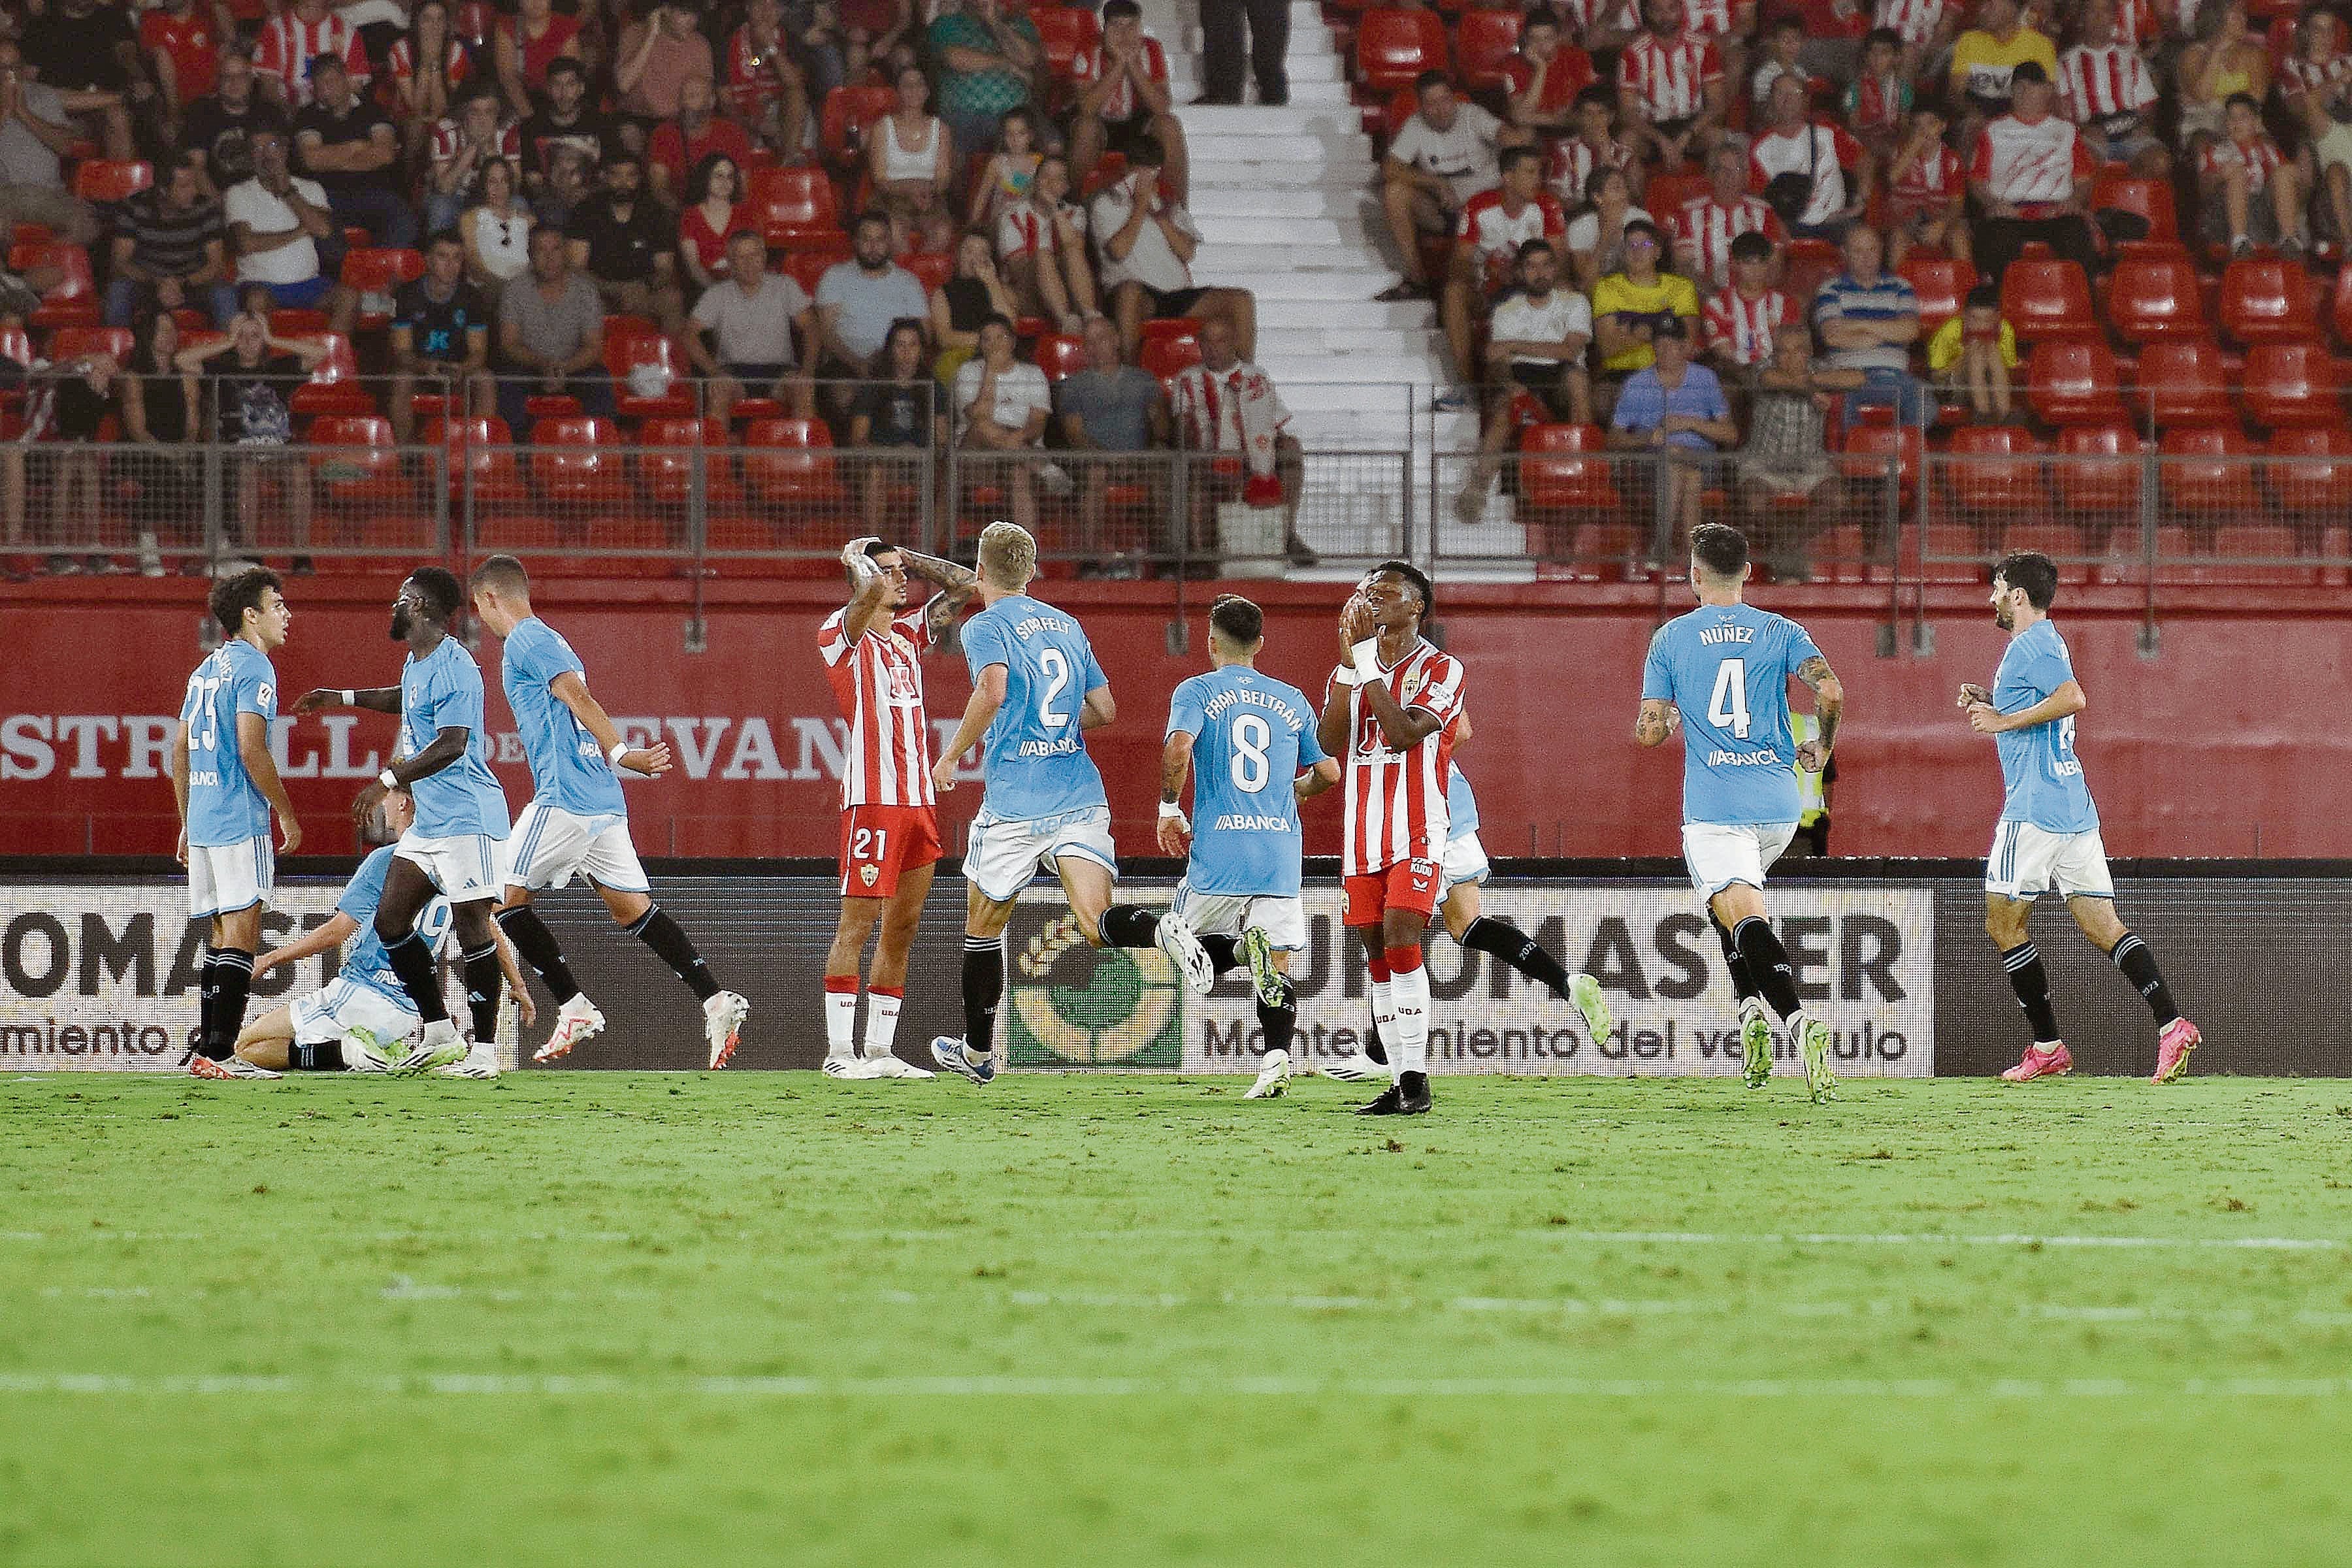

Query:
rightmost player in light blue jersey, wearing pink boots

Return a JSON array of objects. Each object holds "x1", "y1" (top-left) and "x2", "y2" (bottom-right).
[{"x1": 1959, "y1": 553, "x2": 2204, "y2": 1084}]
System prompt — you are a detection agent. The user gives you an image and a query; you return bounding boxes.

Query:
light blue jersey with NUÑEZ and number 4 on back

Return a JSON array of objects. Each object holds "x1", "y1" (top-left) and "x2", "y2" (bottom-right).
[{"x1": 1642, "y1": 604, "x2": 1820, "y2": 828}]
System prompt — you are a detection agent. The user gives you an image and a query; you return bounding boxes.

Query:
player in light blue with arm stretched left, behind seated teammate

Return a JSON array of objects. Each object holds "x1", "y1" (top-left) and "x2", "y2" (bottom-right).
[{"x1": 294, "y1": 566, "x2": 506, "y2": 1079}]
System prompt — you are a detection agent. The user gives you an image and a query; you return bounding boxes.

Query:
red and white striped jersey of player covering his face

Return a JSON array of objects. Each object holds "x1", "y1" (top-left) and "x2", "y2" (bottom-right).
[{"x1": 1324, "y1": 642, "x2": 1463, "y2": 877}]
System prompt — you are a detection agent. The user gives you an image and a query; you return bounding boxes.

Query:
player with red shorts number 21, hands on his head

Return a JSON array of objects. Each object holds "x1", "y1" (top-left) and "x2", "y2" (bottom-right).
[{"x1": 816, "y1": 536, "x2": 979, "y2": 1079}]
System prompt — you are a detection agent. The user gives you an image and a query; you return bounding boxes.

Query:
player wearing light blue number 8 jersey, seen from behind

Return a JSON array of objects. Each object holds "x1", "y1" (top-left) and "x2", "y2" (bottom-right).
[{"x1": 1160, "y1": 595, "x2": 1338, "y2": 1100}]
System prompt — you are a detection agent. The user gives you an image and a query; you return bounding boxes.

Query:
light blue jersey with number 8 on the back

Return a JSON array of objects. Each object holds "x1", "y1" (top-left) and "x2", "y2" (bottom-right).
[{"x1": 1169, "y1": 665, "x2": 1324, "y2": 898}]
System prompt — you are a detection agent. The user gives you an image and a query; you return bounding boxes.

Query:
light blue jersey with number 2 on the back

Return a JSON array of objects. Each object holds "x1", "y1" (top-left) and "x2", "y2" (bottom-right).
[{"x1": 964, "y1": 595, "x2": 1110, "y2": 823}]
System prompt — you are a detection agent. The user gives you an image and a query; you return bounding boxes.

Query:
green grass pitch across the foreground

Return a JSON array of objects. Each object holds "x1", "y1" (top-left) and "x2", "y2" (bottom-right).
[{"x1": 0, "y1": 1074, "x2": 2352, "y2": 1568}]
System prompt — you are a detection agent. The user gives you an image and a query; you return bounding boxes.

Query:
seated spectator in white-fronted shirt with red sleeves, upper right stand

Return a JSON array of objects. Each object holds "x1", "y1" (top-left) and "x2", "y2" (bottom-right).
[{"x1": 1968, "y1": 61, "x2": 2098, "y2": 282}]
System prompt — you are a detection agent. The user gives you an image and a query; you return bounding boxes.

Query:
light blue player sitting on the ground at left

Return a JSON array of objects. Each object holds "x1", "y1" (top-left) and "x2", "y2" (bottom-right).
[{"x1": 238, "y1": 790, "x2": 534, "y2": 1072}]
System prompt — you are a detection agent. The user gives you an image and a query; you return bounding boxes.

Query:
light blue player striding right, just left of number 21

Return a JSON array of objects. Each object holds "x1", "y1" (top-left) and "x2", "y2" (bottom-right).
[{"x1": 468, "y1": 555, "x2": 750, "y2": 1072}]
